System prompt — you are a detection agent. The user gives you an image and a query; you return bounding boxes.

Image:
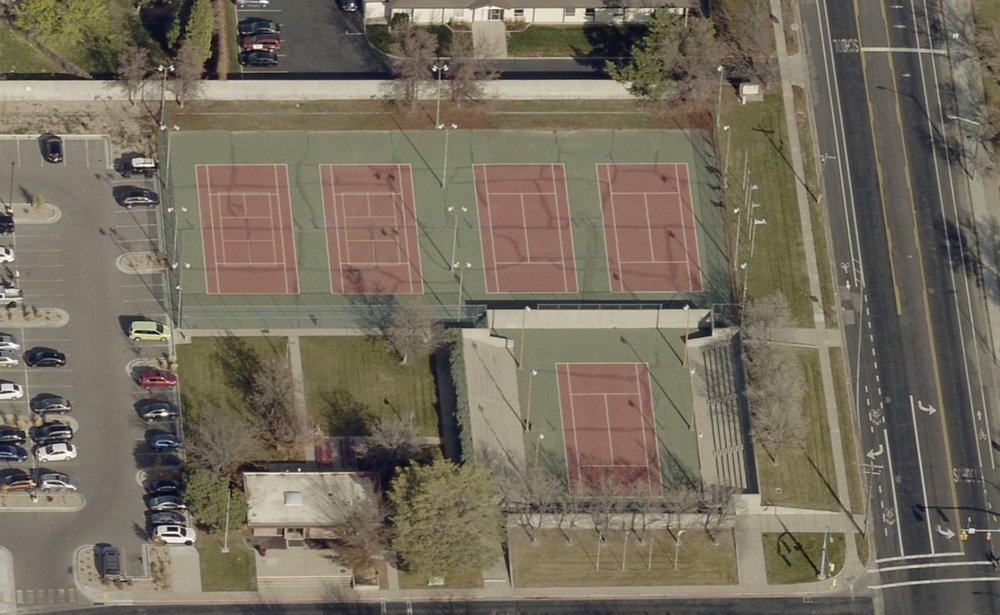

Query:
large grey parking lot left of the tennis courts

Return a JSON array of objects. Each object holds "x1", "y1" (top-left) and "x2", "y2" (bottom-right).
[{"x1": 0, "y1": 137, "x2": 179, "y2": 607}]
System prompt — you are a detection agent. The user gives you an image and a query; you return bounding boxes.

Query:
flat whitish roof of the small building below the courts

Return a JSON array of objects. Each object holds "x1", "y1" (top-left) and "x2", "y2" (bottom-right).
[{"x1": 243, "y1": 472, "x2": 375, "y2": 527}]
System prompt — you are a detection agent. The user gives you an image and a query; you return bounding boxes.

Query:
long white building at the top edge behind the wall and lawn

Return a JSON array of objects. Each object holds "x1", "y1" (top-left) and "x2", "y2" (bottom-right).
[{"x1": 364, "y1": 0, "x2": 700, "y2": 27}]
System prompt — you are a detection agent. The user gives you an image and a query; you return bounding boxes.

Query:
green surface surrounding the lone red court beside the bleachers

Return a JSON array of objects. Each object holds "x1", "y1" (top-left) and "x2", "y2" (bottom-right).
[{"x1": 496, "y1": 329, "x2": 708, "y2": 493}]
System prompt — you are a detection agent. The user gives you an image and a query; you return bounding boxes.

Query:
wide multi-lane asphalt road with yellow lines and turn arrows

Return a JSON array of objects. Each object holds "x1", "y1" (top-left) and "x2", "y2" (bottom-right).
[{"x1": 802, "y1": 0, "x2": 1000, "y2": 615}]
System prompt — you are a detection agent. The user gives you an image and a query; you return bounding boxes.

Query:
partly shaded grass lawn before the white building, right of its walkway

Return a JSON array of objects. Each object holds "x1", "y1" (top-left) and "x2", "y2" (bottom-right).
[{"x1": 507, "y1": 25, "x2": 647, "y2": 58}]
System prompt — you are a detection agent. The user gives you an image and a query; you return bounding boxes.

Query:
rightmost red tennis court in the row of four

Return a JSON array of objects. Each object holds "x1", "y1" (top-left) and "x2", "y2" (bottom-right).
[{"x1": 597, "y1": 164, "x2": 701, "y2": 293}]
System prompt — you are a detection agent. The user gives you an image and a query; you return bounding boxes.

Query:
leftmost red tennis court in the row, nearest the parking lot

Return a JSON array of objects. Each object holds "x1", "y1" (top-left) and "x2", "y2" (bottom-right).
[{"x1": 195, "y1": 164, "x2": 299, "y2": 295}]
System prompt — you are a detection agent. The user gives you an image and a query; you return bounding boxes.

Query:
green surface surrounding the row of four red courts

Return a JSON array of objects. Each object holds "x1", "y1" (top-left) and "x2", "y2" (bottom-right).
[{"x1": 164, "y1": 130, "x2": 728, "y2": 329}]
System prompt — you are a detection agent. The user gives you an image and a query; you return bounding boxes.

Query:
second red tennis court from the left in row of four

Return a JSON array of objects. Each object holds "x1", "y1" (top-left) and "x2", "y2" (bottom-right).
[{"x1": 319, "y1": 164, "x2": 424, "y2": 295}]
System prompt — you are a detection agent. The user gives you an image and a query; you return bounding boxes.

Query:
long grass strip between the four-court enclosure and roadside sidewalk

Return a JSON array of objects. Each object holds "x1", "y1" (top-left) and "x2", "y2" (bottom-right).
[{"x1": 720, "y1": 93, "x2": 813, "y2": 327}]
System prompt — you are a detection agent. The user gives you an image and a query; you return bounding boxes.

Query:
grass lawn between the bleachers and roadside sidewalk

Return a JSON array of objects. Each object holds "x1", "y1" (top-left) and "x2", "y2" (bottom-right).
[{"x1": 757, "y1": 348, "x2": 840, "y2": 510}]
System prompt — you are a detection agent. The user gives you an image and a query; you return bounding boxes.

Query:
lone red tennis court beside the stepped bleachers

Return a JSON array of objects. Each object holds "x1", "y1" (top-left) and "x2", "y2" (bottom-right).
[{"x1": 556, "y1": 363, "x2": 662, "y2": 497}]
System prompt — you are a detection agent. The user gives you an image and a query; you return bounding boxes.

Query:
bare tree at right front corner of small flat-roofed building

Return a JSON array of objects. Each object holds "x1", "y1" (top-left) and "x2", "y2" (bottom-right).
[{"x1": 331, "y1": 491, "x2": 391, "y2": 569}]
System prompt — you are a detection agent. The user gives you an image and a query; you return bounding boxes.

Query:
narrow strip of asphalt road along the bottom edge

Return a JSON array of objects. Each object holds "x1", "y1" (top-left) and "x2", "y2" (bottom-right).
[{"x1": 64, "y1": 598, "x2": 875, "y2": 615}]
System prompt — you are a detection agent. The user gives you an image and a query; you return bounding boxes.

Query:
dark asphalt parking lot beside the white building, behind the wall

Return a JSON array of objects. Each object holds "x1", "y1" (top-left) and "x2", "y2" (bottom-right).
[{"x1": 237, "y1": 0, "x2": 388, "y2": 78}]
